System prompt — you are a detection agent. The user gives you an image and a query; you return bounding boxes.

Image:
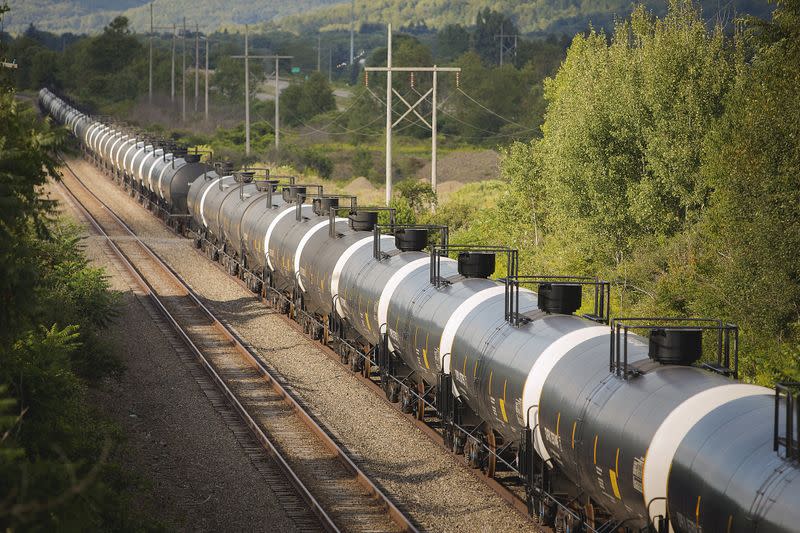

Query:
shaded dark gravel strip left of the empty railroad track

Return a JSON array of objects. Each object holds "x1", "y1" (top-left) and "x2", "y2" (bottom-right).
[{"x1": 47, "y1": 179, "x2": 304, "y2": 531}]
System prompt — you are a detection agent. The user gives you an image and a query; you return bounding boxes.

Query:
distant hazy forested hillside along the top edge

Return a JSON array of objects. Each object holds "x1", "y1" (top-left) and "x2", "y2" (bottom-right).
[{"x1": 5, "y1": 0, "x2": 769, "y2": 35}]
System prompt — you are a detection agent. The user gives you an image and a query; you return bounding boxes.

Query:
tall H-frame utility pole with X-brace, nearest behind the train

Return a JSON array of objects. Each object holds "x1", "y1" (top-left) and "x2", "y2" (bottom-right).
[{"x1": 366, "y1": 24, "x2": 461, "y2": 205}]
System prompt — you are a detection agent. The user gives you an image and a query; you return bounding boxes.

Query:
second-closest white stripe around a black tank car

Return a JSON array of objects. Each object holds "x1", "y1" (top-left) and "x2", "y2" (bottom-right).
[{"x1": 518, "y1": 326, "x2": 610, "y2": 461}]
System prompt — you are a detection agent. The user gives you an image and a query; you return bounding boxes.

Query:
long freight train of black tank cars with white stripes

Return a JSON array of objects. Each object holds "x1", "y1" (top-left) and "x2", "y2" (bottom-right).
[{"x1": 39, "y1": 89, "x2": 800, "y2": 533}]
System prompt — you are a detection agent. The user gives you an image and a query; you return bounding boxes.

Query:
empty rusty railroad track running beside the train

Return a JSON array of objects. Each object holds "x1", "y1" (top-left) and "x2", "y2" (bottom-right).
[{"x1": 56, "y1": 162, "x2": 416, "y2": 531}]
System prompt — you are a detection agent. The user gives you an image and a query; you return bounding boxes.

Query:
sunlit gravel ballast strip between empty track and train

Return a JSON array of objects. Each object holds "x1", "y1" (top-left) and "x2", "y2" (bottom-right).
[{"x1": 61, "y1": 160, "x2": 537, "y2": 532}]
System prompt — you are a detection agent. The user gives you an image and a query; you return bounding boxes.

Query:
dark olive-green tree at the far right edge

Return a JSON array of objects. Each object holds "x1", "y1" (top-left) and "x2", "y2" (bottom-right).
[{"x1": 698, "y1": 0, "x2": 800, "y2": 383}]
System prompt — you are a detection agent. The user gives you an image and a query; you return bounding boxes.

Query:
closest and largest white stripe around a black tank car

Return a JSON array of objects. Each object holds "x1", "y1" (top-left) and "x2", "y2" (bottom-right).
[{"x1": 642, "y1": 383, "x2": 774, "y2": 531}]
